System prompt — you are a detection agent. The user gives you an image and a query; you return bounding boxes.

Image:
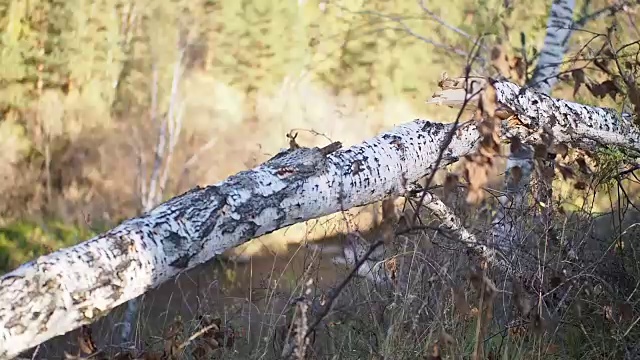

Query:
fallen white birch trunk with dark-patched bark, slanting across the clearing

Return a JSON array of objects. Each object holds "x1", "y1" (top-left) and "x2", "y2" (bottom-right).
[{"x1": 0, "y1": 78, "x2": 640, "y2": 358}]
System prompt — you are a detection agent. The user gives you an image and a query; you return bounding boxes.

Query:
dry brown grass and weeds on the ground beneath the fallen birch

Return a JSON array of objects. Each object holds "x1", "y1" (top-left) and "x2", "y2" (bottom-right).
[{"x1": 20, "y1": 179, "x2": 640, "y2": 360}]
